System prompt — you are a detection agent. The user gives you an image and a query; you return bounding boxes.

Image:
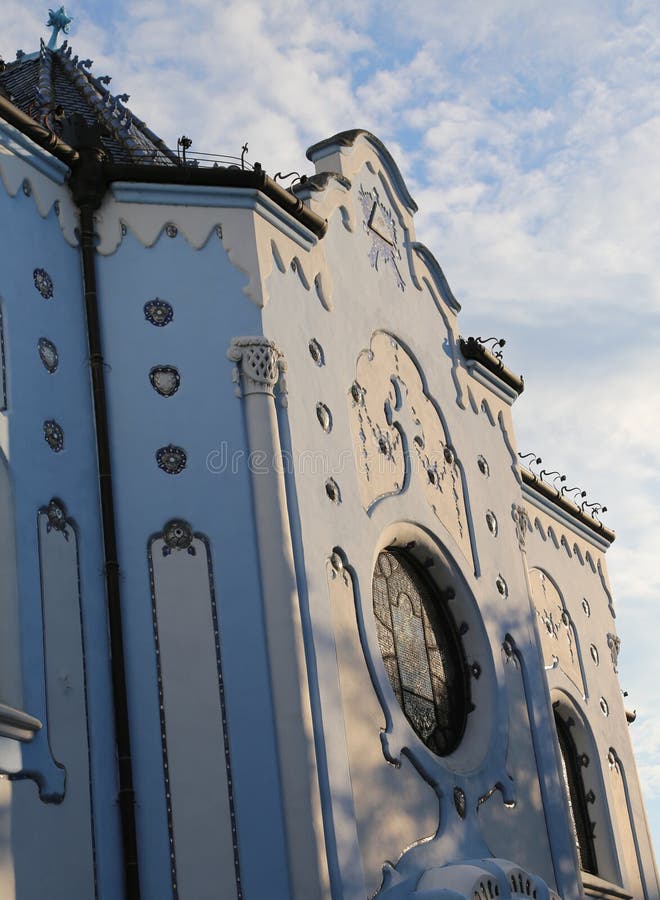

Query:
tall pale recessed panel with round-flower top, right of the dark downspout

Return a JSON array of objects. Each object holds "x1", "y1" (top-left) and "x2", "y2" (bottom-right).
[{"x1": 150, "y1": 536, "x2": 240, "y2": 900}]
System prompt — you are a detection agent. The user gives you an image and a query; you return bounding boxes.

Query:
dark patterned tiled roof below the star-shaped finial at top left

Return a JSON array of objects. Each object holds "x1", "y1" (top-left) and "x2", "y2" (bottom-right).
[{"x1": 0, "y1": 41, "x2": 178, "y2": 165}]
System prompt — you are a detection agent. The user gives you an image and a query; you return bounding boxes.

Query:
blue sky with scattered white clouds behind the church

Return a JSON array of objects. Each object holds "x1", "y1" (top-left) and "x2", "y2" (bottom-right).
[{"x1": 0, "y1": 0, "x2": 660, "y2": 872}]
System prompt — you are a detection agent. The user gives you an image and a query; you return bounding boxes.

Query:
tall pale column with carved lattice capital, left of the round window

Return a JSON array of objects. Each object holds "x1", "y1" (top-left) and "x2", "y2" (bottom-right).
[{"x1": 227, "y1": 336, "x2": 327, "y2": 900}]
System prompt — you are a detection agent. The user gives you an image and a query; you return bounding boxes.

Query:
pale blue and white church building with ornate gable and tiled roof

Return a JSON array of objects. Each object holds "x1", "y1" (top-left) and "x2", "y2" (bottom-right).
[{"x1": 0, "y1": 14, "x2": 660, "y2": 900}]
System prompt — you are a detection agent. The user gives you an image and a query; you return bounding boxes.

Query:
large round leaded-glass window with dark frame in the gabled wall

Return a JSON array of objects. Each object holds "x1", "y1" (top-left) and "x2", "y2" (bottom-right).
[{"x1": 373, "y1": 547, "x2": 470, "y2": 756}]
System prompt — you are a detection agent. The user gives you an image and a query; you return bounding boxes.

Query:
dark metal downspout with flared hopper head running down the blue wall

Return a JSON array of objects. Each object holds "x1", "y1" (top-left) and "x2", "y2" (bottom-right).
[{"x1": 69, "y1": 139, "x2": 140, "y2": 900}]
